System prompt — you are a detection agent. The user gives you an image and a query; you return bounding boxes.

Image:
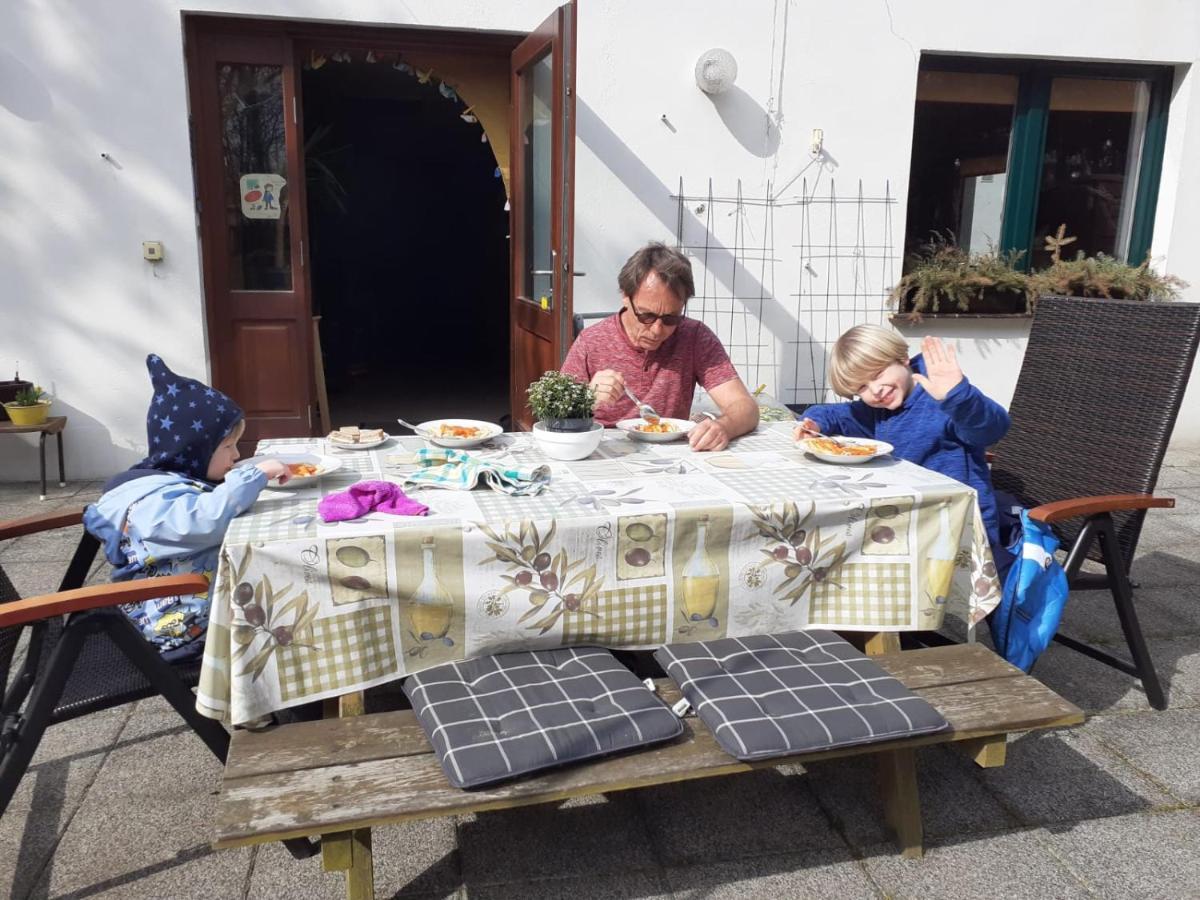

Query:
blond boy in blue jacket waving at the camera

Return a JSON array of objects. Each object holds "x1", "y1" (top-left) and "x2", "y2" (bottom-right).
[{"x1": 794, "y1": 325, "x2": 1012, "y2": 581}]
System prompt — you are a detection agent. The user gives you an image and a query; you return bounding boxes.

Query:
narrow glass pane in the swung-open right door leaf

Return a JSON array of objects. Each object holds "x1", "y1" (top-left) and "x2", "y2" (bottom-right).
[{"x1": 521, "y1": 53, "x2": 554, "y2": 306}]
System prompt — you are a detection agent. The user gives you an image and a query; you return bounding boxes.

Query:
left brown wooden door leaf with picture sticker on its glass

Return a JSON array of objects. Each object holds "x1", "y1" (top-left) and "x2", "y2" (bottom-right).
[{"x1": 187, "y1": 23, "x2": 313, "y2": 451}]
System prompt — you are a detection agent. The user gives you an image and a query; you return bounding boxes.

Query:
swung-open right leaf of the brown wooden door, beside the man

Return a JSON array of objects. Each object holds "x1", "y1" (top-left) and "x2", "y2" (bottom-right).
[{"x1": 509, "y1": 0, "x2": 576, "y2": 428}]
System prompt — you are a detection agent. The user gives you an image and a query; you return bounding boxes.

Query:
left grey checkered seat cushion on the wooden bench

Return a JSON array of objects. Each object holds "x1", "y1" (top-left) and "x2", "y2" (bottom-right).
[{"x1": 404, "y1": 647, "x2": 683, "y2": 787}]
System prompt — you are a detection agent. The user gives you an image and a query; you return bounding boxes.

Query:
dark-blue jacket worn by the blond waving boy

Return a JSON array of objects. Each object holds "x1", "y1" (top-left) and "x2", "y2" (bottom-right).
[{"x1": 803, "y1": 354, "x2": 1009, "y2": 560}]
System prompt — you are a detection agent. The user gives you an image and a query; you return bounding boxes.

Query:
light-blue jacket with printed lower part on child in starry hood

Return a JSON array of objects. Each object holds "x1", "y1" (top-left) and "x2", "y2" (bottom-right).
[{"x1": 83, "y1": 466, "x2": 266, "y2": 661}]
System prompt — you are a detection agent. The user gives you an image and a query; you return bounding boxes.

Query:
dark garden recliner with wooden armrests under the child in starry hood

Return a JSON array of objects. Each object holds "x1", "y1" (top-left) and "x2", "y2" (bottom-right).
[{"x1": 0, "y1": 509, "x2": 316, "y2": 859}]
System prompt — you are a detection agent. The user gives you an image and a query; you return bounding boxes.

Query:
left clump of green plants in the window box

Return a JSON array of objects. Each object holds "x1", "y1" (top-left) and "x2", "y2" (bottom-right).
[{"x1": 888, "y1": 234, "x2": 1034, "y2": 322}]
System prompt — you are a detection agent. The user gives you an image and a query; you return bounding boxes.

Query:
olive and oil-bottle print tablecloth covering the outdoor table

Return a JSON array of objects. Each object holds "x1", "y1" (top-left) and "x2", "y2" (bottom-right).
[{"x1": 197, "y1": 422, "x2": 1000, "y2": 724}]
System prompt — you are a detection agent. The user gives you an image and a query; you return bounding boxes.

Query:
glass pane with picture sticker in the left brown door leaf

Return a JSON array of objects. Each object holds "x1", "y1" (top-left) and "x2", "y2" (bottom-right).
[{"x1": 217, "y1": 64, "x2": 292, "y2": 290}]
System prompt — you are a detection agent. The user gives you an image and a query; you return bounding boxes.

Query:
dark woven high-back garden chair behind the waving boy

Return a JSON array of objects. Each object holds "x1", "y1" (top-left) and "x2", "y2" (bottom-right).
[{"x1": 991, "y1": 296, "x2": 1200, "y2": 709}]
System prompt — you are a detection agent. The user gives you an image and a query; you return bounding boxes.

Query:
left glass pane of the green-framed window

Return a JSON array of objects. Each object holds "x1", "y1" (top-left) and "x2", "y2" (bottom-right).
[{"x1": 905, "y1": 71, "x2": 1018, "y2": 254}]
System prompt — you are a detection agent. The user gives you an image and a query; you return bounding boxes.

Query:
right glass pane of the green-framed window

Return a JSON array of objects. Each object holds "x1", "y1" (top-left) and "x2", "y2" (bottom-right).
[{"x1": 1033, "y1": 78, "x2": 1150, "y2": 268}]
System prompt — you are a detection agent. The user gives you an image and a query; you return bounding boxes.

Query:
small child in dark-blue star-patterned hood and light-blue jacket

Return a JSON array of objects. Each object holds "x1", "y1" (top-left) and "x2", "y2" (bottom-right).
[{"x1": 83, "y1": 354, "x2": 289, "y2": 662}]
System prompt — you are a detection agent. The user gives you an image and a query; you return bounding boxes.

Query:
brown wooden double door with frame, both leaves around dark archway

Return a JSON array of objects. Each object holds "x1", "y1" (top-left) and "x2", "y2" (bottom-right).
[{"x1": 186, "y1": 8, "x2": 576, "y2": 439}]
